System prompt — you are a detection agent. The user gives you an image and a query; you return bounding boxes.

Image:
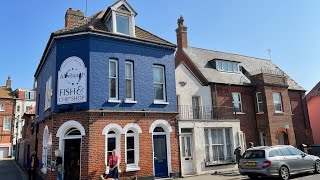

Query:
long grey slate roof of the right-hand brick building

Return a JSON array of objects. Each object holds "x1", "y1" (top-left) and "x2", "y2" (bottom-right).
[{"x1": 183, "y1": 46, "x2": 304, "y2": 90}]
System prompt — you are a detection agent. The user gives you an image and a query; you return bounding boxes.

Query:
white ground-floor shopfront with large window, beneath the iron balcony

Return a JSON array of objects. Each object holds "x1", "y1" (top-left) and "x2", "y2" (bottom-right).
[{"x1": 179, "y1": 120, "x2": 246, "y2": 176}]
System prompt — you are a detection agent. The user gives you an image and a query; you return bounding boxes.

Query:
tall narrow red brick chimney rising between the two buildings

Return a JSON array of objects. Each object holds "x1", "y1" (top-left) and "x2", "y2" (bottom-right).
[{"x1": 176, "y1": 15, "x2": 188, "y2": 49}]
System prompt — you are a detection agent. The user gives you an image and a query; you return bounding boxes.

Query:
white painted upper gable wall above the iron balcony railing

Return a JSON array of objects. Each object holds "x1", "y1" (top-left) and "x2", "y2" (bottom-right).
[{"x1": 176, "y1": 63, "x2": 212, "y2": 106}]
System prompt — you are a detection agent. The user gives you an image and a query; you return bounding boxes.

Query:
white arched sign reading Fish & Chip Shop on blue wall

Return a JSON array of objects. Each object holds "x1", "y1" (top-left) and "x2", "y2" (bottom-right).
[{"x1": 57, "y1": 56, "x2": 87, "y2": 105}]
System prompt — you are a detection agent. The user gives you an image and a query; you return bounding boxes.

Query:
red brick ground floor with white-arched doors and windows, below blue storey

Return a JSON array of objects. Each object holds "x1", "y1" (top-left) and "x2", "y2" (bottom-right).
[{"x1": 38, "y1": 111, "x2": 180, "y2": 180}]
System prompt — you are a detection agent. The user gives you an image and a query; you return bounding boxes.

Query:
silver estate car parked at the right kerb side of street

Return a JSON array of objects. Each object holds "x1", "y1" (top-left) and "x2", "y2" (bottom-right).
[{"x1": 239, "y1": 145, "x2": 320, "y2": 180}]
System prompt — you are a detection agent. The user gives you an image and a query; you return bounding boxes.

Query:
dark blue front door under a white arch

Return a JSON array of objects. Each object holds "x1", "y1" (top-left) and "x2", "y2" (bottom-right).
[{"x1": 153, "y1": 135, "x2": 168, "y2": 178}]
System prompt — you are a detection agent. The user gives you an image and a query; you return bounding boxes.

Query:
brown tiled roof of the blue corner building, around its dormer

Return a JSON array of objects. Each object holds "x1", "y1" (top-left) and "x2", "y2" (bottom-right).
[{"x1": 53, "y1": 10, "x2": 175, "y2": 47}]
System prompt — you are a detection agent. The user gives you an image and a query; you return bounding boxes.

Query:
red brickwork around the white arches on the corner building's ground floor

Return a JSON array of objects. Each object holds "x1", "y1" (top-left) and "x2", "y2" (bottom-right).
[{"x1": 38, "y1": 112, "x2": 180, "y2": 179}]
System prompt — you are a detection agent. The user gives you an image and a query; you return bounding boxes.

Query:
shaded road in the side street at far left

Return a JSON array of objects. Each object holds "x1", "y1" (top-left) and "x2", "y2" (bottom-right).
[{"x1": 0, "y1": 159, "x2": 25, "y2": 180}]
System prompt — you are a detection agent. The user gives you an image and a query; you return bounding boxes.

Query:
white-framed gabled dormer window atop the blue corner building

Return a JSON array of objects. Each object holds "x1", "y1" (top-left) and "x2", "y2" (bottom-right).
[{"x1": 104, "y1": 0, "x2": 137, "y2": 37}]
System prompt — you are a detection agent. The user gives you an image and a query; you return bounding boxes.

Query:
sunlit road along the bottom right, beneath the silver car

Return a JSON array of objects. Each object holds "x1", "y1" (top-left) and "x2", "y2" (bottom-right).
[{"x1": 183, "y1": 173, "x2": 320, "y2": 180}]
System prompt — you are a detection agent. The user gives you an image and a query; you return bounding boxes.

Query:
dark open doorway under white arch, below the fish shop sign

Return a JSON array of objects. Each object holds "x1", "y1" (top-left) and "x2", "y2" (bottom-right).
[{"x1": 64, "y1": 139, "x2": 81, "y2": 180}]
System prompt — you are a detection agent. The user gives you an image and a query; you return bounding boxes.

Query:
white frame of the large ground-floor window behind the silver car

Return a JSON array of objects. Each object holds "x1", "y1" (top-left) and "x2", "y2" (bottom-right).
[{"x1": 203, "y1": 127, "x2": 234, "y2": 165}]
